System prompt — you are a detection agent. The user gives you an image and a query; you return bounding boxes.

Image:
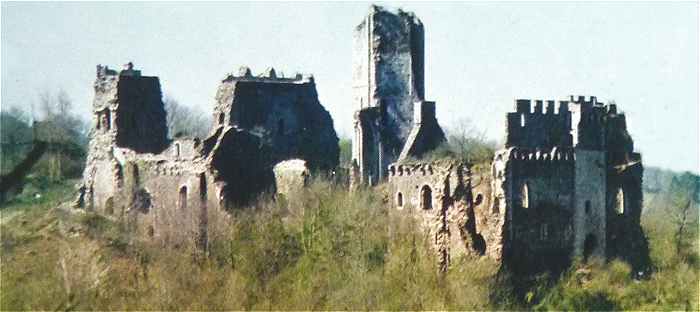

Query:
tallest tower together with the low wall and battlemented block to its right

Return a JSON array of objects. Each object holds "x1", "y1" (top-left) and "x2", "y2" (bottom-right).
[{"x1": 366, "y1": 7, "x2": 647, "y2": 272}]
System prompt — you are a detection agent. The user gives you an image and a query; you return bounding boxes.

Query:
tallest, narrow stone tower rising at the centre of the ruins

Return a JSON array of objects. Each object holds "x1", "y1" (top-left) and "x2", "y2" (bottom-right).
[{"x1": 353, "y1": 5, "x2": 424, "y2": 184}]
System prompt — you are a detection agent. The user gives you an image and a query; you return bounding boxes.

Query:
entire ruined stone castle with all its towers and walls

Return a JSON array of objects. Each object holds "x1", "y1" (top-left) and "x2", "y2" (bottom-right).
[{"x1": 75, "y1": 6, "x2": 648, "y2": 272}]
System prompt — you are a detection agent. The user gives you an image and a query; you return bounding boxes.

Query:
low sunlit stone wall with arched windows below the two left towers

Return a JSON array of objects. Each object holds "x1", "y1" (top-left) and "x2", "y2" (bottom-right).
[{"x1": 84, "y1": 143, "x2": 225, "y2": 244}]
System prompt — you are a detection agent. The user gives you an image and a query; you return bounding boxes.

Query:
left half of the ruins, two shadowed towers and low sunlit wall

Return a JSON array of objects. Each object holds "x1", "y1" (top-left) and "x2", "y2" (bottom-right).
[{"x1": 75, "y1": 64, "x2": 338, "y2": 247}]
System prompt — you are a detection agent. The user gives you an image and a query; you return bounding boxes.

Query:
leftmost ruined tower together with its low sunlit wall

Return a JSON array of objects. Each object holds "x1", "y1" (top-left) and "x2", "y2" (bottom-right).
[{"x1": 75, "y1": 64, "x2": 232, "y2": 246}]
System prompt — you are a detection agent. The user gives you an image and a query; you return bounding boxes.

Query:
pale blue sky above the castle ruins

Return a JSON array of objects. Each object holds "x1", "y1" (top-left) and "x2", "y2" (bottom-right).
[{"x1": 2, "y1": 2, "x2": 699, "y2": 172}]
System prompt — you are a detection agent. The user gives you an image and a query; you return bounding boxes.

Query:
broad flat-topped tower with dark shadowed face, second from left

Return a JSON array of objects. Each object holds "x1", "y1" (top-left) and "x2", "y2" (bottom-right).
[{"x1": 215, "y1": 70, "x2": 339, "y2": 170}]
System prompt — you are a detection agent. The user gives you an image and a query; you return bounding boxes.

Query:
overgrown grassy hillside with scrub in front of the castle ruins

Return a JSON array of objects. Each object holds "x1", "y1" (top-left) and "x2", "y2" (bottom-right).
[{"x1": 0, "y1": 176, "x2": 700, "y2": 310}]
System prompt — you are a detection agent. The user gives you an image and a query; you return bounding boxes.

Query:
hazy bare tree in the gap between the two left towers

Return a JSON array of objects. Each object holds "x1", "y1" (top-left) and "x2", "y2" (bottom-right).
[{"x1": 163, "y1": 96, "x2": 211, "y2": 138}]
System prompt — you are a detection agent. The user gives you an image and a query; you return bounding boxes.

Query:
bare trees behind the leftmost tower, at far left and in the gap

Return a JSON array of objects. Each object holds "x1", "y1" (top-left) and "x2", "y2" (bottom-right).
[{"x1": 0, "y1": 89, "x2": 211, "y2": 199}]
